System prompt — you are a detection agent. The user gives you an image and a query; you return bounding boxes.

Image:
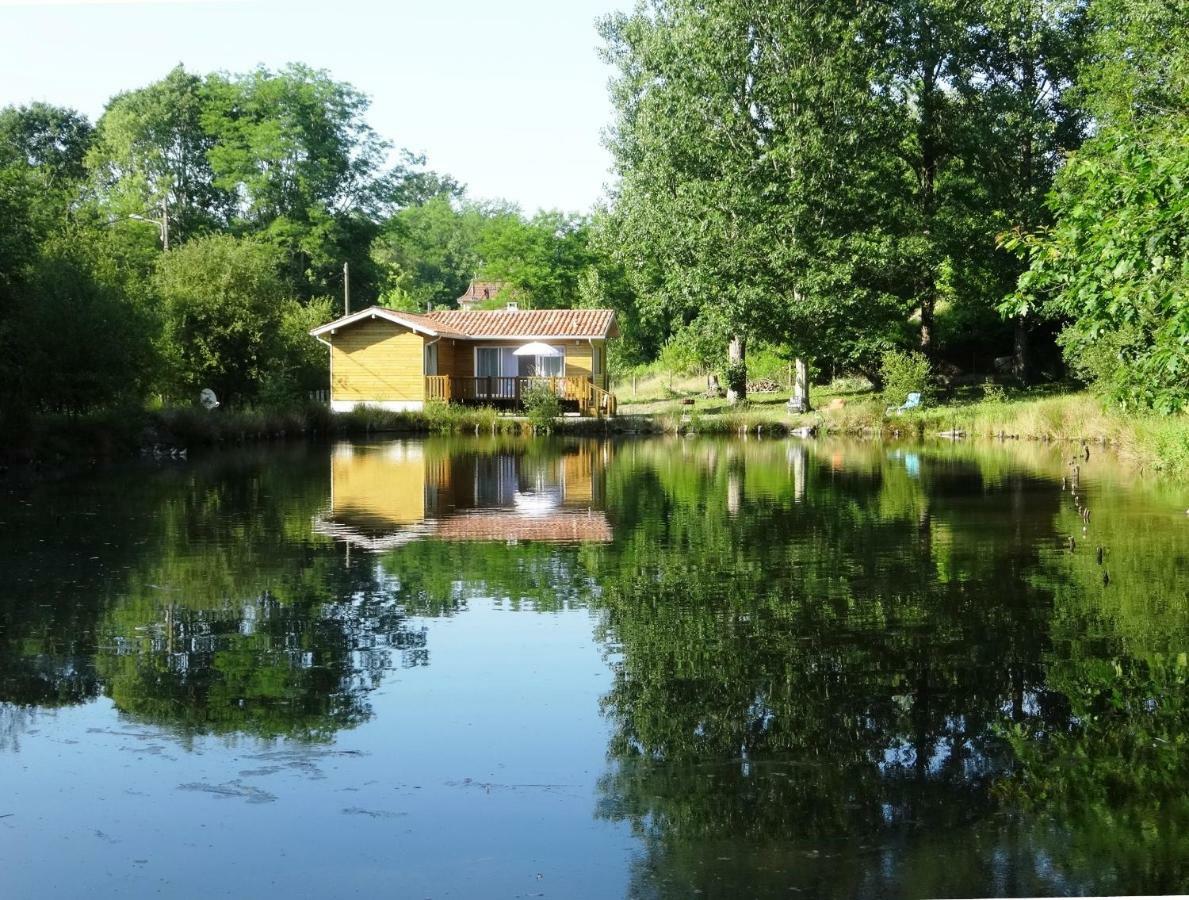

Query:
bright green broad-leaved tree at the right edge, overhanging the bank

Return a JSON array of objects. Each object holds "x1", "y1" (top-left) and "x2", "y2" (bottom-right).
[{"x1": 1005, "y1": 0, "x2": 1189, "y2": 411}]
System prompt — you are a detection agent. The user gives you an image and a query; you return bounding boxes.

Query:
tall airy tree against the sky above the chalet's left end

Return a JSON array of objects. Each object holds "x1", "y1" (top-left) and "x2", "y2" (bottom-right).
[{"x1": 202, "y1": 64, "x2": 423, "y2": 296}]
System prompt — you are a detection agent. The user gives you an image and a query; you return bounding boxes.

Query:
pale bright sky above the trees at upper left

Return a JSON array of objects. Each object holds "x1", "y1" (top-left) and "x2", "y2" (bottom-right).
[{"x1": 0, "y1": 0, "x2": 630, "y2": 212}]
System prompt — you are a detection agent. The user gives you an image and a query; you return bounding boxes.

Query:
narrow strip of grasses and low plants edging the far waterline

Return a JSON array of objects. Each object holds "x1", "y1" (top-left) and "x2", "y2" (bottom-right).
[{"x1": 0, "y1": 394, "x2": 1189, "y2": 477}]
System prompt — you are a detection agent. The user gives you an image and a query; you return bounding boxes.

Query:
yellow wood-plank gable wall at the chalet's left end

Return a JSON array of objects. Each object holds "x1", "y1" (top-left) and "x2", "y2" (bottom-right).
[{"x1": 329, "y1": 319, "x2": 426, "y2": 402}]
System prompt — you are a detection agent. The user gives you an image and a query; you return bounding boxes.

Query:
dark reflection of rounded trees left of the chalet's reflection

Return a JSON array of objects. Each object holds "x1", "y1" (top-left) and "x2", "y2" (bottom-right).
[{"x1": 0, "y1": 452, "x2": 427, "y2": 738}]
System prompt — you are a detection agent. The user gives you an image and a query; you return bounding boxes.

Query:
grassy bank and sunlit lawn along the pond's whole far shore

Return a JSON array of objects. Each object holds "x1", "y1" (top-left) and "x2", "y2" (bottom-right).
[{"x1": 9, "y1": 377, "x2": 1189, "y2": 477}]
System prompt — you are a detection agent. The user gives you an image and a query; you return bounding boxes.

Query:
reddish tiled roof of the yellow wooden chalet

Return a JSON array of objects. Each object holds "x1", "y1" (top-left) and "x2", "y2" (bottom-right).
[{"x1": 310, "y1": 307, "x2": 619, "y2": 340}]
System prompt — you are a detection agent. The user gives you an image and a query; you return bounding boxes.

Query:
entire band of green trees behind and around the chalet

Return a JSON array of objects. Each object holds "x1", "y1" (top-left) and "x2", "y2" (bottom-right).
[{"x1": 0, "y1": 0, "x2": 1189, "y2": 421}]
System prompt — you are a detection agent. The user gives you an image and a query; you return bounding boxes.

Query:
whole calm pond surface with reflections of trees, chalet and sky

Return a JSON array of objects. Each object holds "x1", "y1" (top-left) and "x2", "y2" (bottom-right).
[{"x1": 0, "y1": 439, "x2": 1189, "y2": 898}]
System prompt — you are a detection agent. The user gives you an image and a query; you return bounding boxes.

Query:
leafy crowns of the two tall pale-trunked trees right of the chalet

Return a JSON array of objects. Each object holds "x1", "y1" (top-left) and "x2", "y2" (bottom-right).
[{"x1": 603, "y1": 0, "x2": 906, "y2": 388}]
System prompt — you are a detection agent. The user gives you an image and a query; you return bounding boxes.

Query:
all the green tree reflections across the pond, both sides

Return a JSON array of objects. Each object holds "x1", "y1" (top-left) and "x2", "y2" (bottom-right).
[{"x1": 0, "y1": 432, "x2": 1189, "y2": 896}]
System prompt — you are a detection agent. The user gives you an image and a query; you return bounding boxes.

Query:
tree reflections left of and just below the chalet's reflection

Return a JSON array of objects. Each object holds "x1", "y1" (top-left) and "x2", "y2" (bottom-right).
[{"x1": 0, "y1": 445, "x2": 599, "y2": 738}]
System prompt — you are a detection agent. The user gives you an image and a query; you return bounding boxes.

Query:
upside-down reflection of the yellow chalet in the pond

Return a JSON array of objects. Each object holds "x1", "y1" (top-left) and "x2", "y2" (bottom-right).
[{"x1": 315, "y1": 441, "x2": 611, "y2": 550}]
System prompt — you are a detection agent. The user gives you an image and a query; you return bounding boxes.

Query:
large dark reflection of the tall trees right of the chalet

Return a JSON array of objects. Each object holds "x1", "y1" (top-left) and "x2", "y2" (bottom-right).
[{"x1": 589, "y1": 449, "x2": 1185, "y2": 896}]
